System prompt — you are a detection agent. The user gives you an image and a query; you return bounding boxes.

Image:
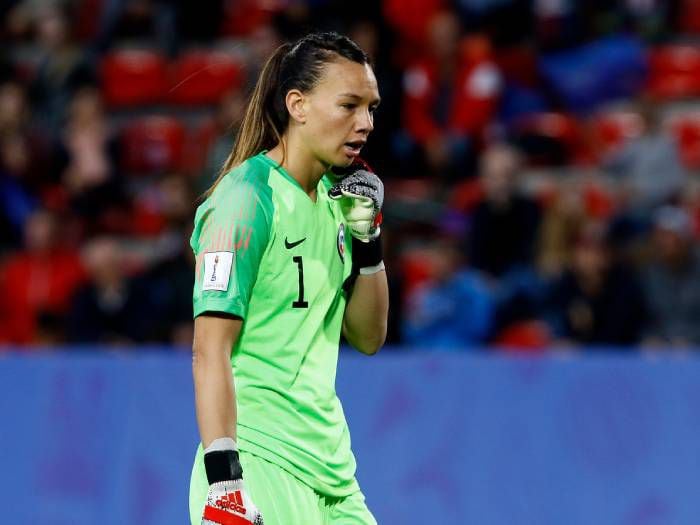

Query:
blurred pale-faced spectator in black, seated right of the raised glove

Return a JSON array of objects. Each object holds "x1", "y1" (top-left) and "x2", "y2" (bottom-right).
[{"x1": 467, "y1": 144, "x2": 540, "y2": 278}]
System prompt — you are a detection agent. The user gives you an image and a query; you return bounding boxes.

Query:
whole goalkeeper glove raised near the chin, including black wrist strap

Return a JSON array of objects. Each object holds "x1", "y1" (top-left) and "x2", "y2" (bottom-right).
[{"x1": 328, "y1": 159, "x2": 384, "y2": 275}]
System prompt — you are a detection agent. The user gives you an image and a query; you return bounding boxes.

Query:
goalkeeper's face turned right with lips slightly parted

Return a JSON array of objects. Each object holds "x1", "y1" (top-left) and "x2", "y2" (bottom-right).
[{"x1": 300, "y1": 58, "x2": 379, "y2": 166}]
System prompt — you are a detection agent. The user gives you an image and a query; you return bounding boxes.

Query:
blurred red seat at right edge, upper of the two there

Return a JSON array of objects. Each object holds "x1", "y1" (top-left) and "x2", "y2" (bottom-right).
[{"x1": 647, "y1": 45, "x2": 700, "y2": 99}]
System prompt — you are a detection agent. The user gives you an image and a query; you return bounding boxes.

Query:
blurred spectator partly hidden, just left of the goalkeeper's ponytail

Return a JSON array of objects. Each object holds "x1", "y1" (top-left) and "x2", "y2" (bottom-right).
[{"x1": 196, "y1": 89, "x2": 246, "y2": 194}]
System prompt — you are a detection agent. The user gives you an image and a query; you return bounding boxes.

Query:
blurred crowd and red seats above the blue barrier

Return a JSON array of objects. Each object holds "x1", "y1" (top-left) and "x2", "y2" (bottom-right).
[{"x1": 0, "y1": 0, "x2": 700, "y2": 351}]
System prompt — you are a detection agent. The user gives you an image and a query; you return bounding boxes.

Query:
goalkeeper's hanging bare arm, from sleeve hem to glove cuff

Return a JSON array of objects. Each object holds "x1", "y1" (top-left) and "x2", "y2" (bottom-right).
[{"x1": 192, "y1": 315, "x2": 243, "y2": 448}]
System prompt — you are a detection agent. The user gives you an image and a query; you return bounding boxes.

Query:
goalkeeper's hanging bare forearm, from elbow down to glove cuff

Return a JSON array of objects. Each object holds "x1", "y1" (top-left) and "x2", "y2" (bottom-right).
[{"x1": 192, "y1": 352, "x2": 236, "y2": 448}]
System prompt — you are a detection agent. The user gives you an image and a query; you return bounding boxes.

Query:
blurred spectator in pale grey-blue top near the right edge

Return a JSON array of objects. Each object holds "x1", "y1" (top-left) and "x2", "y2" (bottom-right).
[{"x1": 606, "y1": 100, "x2": 687, "y2": 214}]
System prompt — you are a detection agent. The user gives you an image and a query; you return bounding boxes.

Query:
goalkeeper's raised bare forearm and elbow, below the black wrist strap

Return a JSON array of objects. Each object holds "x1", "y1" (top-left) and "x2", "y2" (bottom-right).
[{"x1": 343, "y1": 270, "x2": 389, "y2": 355}]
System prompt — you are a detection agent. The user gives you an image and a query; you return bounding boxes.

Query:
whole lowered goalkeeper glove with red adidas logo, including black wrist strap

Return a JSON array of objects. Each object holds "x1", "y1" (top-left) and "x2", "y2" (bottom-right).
[{"x1": 202, "y1": 438, "x2": 264, "y2": 525}]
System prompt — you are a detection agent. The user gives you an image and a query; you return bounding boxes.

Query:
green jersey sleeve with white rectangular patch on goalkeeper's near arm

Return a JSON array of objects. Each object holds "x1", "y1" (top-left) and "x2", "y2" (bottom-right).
[{"x1": 190, "y1": 174, "x2": 272, "y2": 318}]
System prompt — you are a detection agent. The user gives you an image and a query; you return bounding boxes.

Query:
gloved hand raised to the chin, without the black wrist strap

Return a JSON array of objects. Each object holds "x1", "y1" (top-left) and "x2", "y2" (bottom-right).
[{"x1": 328, "y1": 168, "x2": 384, "y2": 242}]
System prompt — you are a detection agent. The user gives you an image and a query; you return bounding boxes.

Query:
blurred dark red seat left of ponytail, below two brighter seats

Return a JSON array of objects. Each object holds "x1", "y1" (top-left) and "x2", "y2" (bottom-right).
[{"x1": 122, "y1": 116, "x2": 185, "y2": 173}]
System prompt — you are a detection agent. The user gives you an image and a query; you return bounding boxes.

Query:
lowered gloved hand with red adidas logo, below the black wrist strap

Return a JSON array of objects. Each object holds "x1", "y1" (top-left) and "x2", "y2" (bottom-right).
[{"x1": 202, "y1": 478, "x2": 264, "y2": 525}]
